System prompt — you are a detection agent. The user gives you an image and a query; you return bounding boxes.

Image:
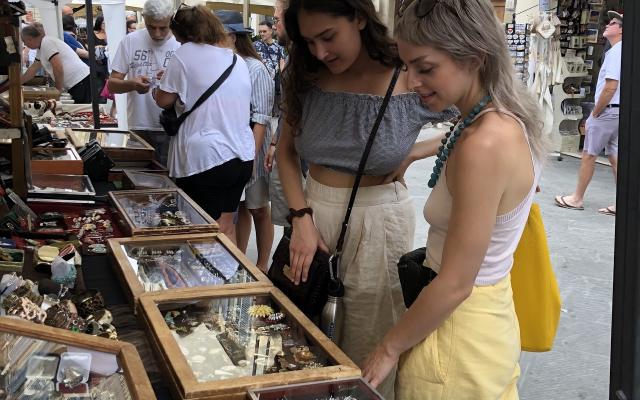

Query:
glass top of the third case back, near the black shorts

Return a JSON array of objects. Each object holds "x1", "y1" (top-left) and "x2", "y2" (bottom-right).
[{"x1": 115, "y1": 191, "x2": 210, "y2": 228}]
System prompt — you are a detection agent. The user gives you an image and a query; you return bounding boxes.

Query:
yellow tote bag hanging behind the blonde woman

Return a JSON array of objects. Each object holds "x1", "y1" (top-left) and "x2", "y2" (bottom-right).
[{"x1": 511, "y1": 204, "x2": 561, "y2": 352}]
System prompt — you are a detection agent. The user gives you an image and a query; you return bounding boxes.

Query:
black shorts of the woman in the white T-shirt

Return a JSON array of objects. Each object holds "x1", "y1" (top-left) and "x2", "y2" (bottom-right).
[{"x1": 176, "y1": 158, "x2": 253, "y2": 220}]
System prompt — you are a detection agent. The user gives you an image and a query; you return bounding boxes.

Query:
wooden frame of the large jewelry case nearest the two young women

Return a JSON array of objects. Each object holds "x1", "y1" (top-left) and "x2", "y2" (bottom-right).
[{"x1": 140, "y1": 287, "x2": 361, "y2": 400}]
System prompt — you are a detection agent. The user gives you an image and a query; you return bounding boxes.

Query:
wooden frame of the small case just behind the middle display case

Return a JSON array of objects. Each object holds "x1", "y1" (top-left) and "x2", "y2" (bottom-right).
[{"x1": 109, "y1": 188, "x2": 220, "y2": 236}]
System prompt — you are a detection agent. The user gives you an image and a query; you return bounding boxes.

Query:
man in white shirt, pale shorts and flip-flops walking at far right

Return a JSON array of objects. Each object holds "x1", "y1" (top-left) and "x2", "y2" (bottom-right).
[{"x1": 555, "y1": 11, "x2": 622, "y2": 215}]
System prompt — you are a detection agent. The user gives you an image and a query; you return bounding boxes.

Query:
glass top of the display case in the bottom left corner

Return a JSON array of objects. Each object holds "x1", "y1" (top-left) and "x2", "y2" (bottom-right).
[{"x1": 0, "y1": 333, "x2": 132, "y2": 400}]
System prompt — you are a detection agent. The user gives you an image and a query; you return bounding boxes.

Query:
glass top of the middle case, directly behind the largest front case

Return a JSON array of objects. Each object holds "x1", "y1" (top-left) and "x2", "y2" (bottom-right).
[{"x1": 121, "y1": 239, "x2": 257, "y2": 291}]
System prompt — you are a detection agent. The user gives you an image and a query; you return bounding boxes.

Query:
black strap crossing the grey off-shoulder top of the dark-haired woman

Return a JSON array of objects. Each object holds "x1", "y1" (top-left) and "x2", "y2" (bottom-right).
[{"x1": 331, "y1": 67, "x2": 400, "y2": 280}]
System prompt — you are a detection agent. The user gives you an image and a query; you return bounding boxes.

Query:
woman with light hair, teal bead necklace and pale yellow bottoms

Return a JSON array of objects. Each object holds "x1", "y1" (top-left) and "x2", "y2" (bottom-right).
[{"x1": 363, "y1": 0, "x2": 545, "y2": 400}]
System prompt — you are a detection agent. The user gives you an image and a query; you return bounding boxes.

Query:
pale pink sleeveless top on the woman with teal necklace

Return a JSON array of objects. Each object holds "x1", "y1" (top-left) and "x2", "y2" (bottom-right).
[{"x1": 424, "y1": 108, "x2": 542, "y2": 286}]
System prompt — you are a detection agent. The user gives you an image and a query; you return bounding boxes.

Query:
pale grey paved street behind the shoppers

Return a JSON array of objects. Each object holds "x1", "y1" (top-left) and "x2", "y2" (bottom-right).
[{"x1": 248, "y1": 130, "x2": 615, "y2": 400}]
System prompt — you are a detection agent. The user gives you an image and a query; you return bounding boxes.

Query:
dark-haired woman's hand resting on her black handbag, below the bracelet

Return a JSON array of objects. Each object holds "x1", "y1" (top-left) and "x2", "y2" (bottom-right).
[{"x1": 289, "y1": 214, "x2": 329, "y2": 285}]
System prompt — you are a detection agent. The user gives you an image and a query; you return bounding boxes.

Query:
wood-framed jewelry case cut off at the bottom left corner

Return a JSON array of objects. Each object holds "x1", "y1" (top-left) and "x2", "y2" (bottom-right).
[{"x1": 0, "y1": 317, "x2": 155, "y2": 400}]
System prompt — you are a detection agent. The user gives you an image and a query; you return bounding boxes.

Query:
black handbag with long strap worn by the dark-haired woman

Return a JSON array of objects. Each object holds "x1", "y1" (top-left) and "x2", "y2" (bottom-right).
[{"x1": 268, "y1": 68, "x2": 400, "y2": 318}]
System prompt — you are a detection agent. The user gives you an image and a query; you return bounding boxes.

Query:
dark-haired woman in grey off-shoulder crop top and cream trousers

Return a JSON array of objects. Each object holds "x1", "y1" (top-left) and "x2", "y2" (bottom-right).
[{"x1": 276, "y1": 0, "x2": 453, "y2": 399}]
